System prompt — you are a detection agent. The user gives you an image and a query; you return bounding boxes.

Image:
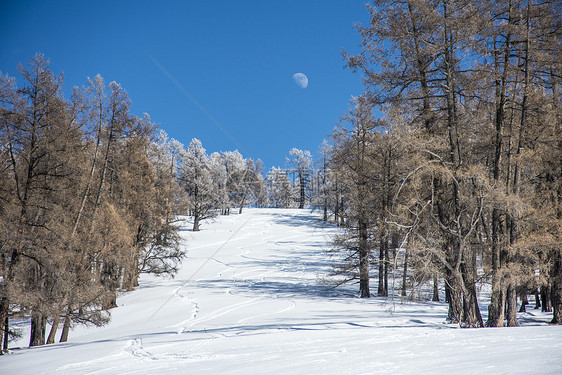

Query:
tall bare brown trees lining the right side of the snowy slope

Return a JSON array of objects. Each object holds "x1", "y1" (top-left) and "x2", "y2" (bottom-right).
[{"x1": 323, "y1": 0, "x2": 562, "y2": 327}]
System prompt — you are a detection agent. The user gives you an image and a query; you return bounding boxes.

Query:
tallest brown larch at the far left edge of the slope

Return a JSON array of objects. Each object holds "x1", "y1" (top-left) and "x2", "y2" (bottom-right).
[{"x1": 0, "y1": 55, "x2": 86, "y2": 346}]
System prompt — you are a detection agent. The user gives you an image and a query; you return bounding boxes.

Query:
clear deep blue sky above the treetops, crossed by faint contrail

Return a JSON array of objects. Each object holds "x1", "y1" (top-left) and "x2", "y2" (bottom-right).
[{"x1": 0, "y1": 0, "x2": 368, "y2": 169}]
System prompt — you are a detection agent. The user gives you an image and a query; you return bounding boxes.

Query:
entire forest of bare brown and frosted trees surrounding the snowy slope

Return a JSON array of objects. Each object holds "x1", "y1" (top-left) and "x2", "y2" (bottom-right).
[{"x1": 0, "y1": 0, "x2": 562, "y2": 352}]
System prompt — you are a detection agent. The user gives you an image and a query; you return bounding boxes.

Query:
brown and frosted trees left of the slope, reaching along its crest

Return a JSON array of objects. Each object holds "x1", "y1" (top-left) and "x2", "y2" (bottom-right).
[{"x1": 0, "y1": 54, "x2": 322, "y2": 353}]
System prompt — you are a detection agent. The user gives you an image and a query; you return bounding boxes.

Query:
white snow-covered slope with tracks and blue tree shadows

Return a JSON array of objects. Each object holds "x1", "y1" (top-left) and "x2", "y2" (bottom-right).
[{"x1": 0, "y1": 209, "x2": 562, "y2": 375}]
